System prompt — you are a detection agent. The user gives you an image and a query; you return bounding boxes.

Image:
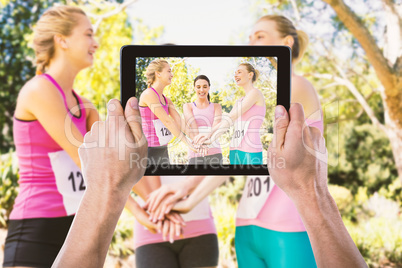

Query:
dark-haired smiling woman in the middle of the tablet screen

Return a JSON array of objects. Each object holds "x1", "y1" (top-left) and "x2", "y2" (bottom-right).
[{"x1": 183, "y1": 75, "x2": 222, "y2": 165}]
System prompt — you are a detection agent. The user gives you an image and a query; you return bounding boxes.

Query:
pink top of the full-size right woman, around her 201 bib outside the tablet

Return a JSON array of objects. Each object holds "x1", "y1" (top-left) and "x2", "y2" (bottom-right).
[{"x1": 236, "y1": 119, "x2": 324, "y2": 232}]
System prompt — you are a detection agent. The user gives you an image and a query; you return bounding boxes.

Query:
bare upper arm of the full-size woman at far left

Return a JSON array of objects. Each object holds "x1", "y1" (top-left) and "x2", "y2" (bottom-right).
[{"x1": 16, "y1": 77, "x2": 84, "y2": 168}]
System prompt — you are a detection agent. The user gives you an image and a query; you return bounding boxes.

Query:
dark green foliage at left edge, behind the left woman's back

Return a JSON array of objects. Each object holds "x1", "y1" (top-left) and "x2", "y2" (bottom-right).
[{"x1": 0, "y1": 0, "x2": 64, "y2": 154}]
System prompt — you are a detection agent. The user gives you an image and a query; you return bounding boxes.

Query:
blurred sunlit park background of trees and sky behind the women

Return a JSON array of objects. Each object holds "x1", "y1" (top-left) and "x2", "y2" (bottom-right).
[{"x1": 0, "y1": 0, "x2": 402, "y2": 267}]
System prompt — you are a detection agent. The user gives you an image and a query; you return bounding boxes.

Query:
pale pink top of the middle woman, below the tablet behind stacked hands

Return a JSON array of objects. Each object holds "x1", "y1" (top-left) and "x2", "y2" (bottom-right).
[{"x1": 134, "y1": 176, "x2": 216, "y2": 248}]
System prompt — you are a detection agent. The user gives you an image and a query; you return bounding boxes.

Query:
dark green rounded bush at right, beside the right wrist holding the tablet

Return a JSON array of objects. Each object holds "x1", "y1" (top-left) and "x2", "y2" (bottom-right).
[{"x1": 329, "y1": 124, "x2": 401, "y2": 195}]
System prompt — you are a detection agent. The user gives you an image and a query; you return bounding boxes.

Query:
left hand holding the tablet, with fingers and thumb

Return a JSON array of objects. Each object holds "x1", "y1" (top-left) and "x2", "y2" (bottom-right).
[{"x1": 78, "y1": 97, "x2": 148, "y2": 198}]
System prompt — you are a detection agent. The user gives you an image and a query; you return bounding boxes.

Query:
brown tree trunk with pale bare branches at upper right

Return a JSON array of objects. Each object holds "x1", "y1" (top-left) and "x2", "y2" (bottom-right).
[{"x1": 324, "y1": 0, "x2": 402, "y2": 181}]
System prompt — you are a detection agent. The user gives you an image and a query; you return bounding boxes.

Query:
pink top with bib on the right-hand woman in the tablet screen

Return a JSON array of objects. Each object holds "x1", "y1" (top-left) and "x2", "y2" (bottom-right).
[{"x1": 230, "y1": 97, "x2": 266, "y2": 153}]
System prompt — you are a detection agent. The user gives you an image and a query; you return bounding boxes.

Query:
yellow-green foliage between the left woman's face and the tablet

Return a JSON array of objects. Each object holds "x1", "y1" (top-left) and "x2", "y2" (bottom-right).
[{"x1": 74, "y1": 2, "x2": 137, "y2": 117}]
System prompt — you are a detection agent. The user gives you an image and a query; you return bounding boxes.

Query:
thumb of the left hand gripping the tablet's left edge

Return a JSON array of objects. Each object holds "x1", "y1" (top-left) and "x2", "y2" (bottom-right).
[{"x1": 124, "y1": 97, "x2": 145, "y2": 142}]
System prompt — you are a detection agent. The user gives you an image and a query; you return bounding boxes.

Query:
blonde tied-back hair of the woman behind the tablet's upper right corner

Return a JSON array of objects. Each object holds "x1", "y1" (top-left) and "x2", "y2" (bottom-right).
[{"x1": 257, "y1": 15, "x2": 308, "y2": 63}]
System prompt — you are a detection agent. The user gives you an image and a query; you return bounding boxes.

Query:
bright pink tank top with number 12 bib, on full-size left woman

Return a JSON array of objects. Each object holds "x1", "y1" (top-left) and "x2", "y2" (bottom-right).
[{"x1": 10, "y1": 74, "x2": 87, "y2": 219}]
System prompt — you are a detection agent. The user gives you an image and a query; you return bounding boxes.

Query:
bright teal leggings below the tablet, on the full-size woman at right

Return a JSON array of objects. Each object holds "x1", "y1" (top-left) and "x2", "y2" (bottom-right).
[{"x1": 235, "y1": 225, "x2": 317, "y2": 268}]
